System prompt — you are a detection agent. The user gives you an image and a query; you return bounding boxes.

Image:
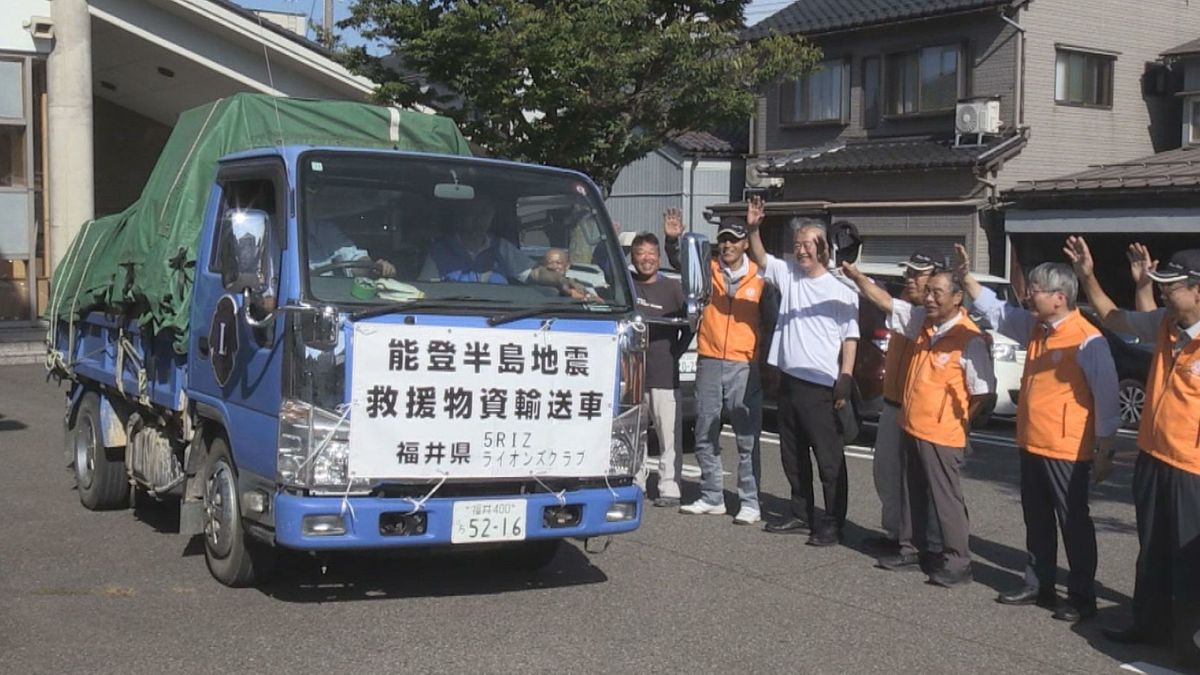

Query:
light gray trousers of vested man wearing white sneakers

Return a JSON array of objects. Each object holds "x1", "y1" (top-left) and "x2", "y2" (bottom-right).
[{"x1": 696, "y1": 357, "x2": 762, "y2": 510}]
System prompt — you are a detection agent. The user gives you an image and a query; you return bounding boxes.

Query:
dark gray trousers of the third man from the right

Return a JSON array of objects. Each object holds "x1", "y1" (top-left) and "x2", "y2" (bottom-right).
[{"x1": 900, "y1": 434, "x2": 971, "y2": 572}]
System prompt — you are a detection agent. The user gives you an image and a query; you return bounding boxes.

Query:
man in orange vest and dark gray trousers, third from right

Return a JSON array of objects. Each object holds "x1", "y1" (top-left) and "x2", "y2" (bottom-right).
[{"x1": 842, "y1": 263, "x2": 996, "y2": 589}]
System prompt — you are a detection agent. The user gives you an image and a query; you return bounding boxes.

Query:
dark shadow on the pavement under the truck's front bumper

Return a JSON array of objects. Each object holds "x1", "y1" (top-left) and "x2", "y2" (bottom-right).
[{"x1": 259, "y1": 543, "x2": 608, "y2": 603}]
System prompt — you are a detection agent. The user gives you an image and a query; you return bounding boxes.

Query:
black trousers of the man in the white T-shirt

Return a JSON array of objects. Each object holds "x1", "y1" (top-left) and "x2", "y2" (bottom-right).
[{"x1": 779, "y1": 372, "x2": 848, "y2": 531}]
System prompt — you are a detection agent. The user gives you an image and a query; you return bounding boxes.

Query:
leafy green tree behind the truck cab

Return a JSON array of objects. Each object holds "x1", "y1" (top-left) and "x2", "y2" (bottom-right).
[{"x1": 338, "y1": 0, "x2": 820, "y2": 190}]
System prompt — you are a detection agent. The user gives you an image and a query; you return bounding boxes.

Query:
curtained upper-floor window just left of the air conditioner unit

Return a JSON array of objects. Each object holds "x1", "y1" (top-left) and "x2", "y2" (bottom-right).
[{"x1": 886, "y1": 44, "x2": 961, "y2": 115}]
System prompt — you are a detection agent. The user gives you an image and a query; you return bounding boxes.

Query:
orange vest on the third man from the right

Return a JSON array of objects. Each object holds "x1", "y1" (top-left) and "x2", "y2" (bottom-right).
[{"x1": 900, "y1": 309, "x2": 983, "y2": 448}]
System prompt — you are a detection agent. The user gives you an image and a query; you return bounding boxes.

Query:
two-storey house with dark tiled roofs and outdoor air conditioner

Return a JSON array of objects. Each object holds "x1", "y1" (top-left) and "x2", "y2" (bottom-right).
[{"x1": 729, "y1": 0, "x2": 1200, "y2": 276}]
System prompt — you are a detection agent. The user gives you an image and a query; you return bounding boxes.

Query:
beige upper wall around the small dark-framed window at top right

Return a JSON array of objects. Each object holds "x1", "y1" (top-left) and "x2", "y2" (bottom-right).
[{"x1": 1000, "y1": 0, "x2": 1200, "y2": 189}]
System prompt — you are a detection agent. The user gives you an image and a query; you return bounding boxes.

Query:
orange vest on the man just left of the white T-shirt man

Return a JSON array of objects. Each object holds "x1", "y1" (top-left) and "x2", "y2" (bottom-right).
[{"x1": 696, "y1": 259, "x2": 766, "y2": 363}]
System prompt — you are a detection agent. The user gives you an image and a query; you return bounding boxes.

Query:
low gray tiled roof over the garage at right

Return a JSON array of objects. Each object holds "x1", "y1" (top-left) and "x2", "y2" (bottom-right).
[{"x1": 1008, "y1": 148, "x2": 1200, "y2": 198}]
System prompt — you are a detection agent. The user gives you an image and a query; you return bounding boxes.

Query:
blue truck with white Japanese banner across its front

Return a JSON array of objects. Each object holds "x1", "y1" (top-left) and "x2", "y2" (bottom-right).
[{"x1": 49, "y1": 94, "x2": 698, "y2": 586}]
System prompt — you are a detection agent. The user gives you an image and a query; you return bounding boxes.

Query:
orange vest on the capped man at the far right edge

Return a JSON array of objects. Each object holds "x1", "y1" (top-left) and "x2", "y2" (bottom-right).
[{"x1": 1138, "y1": 317, "x2": 1200, "y2": 474}]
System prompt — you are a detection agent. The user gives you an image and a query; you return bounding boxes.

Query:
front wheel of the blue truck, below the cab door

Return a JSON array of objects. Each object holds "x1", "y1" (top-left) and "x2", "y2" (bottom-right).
[{"x1": 204, "y1": 436, "x2": 275, "y2": 589}]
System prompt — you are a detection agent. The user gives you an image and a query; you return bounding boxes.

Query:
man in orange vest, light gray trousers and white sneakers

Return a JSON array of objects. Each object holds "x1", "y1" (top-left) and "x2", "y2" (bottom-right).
[{"x1": 662, "y1": 209, "x2": 766, "y2": 525}]
